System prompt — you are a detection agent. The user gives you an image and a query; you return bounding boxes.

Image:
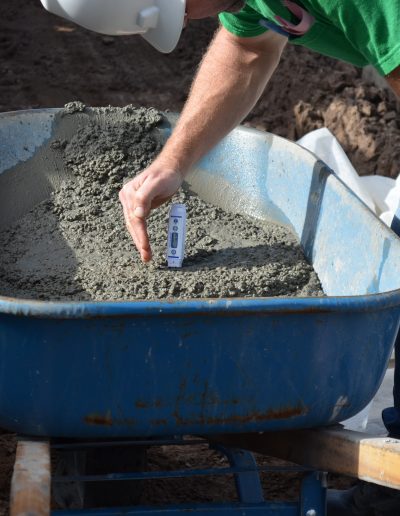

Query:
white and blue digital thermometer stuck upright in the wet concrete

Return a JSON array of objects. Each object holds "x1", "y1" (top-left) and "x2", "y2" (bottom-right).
[{"x1": 167, "y1": 204, "x2": 186, "y2": 267}]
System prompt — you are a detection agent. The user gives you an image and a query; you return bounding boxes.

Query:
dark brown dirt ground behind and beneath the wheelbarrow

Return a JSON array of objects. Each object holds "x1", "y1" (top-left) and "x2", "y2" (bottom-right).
[{"x1": 0, "y1": 0, "x2": 400, "y2": 514}]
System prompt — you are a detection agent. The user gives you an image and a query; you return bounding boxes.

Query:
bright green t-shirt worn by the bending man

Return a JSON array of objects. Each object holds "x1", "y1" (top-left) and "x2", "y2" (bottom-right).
[{"x1": 220, "y1": 0, "x2": 400, "y2": 75}]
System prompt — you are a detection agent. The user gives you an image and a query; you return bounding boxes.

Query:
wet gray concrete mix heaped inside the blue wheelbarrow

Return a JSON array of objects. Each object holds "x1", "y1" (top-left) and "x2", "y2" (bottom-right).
[{"x1": 0, "y1": 103, "x2": 322, "y2": 301}]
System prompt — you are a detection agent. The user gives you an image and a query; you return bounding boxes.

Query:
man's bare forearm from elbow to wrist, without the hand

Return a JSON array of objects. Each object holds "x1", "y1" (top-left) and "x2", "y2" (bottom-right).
[{"x1": 159, "y1": 29, "x2": 286, "y2": 175}]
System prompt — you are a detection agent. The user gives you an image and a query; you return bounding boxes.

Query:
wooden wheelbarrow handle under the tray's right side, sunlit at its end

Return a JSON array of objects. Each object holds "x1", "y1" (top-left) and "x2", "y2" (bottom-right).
[{"x1": 211, "y1": 427, "x2": 400, "y2": 489}]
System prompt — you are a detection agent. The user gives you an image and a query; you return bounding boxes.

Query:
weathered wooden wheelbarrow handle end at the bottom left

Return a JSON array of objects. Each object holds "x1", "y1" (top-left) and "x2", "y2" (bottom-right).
[{"x1": 10, "y1": 439, "x2": 51, "y2": 516}]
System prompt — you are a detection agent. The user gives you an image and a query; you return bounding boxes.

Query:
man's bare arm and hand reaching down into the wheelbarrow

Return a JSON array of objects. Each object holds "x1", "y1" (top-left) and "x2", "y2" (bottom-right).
[{"x1": 120, "y1": 28, "x2": 287, "y2": 262}]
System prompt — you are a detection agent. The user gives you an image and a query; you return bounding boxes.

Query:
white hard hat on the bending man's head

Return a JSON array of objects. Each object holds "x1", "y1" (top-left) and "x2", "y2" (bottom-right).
[{"x1": 41, "y1": 0, "x2": 186, "y2": 52}]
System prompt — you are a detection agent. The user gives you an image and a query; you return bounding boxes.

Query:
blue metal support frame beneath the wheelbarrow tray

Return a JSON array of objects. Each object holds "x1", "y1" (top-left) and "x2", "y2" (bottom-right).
[{"x1": 51, "y1": 439, "x2": 326, "y2": 516}]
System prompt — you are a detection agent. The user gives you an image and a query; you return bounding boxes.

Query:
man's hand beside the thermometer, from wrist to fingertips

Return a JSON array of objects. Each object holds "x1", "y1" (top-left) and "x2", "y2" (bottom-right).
[{"x1": 119, "y1": 162, "x2": 183, "y2": 262}]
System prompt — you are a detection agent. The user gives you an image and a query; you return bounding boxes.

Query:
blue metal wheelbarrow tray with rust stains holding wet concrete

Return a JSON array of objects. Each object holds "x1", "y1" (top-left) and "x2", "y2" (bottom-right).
[{"x1": 0, "y1": 109, "x2": 400, "y2": 438}]
